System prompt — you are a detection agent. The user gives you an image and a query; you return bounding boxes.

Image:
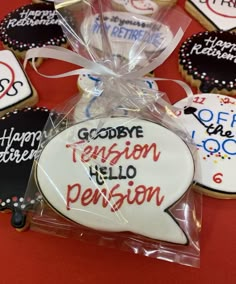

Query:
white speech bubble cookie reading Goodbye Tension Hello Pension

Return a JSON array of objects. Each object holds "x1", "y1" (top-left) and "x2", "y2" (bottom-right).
[{"x1": 35, "y1": 117, "x2": 194, "y2": 244}]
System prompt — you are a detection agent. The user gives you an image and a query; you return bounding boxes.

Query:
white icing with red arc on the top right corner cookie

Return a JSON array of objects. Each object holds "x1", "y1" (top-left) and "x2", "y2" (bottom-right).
[{"x1": 187, "y1": 0, "x2": 236, "y2": 31}]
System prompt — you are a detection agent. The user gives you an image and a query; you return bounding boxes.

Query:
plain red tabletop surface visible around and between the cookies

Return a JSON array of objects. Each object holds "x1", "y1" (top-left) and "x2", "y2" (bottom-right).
[{"x1": 0, "y1": 0, "x2": 236, "y2": 283}]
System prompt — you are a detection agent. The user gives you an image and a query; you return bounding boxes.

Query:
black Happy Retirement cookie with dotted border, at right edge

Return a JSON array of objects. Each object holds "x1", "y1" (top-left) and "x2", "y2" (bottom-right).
[{"x1": 179, "y1": 31, "x2": 236, "y2": 95}]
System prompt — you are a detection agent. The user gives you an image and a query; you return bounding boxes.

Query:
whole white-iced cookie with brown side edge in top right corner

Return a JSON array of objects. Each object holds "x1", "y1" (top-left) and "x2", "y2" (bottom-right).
[{"x1": 185, "y1": 0, "x2": 236, "y2": 31}]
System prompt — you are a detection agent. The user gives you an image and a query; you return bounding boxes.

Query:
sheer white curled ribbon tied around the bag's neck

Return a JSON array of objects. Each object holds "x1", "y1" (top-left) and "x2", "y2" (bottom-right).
[{"x1": 24, "y1": 28, "x2": 193, "y2": 113}]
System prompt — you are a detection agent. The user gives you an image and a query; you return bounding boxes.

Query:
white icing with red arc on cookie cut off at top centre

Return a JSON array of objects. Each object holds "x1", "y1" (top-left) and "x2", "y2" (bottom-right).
[{"x1": 112, "y1": 0, "x2": 158, "y2": 15}]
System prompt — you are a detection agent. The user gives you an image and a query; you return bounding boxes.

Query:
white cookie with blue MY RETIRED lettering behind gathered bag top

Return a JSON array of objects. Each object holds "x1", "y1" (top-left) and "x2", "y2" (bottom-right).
[{"x1": 81, "y1": 12, "x2": 173, "y2": 60}]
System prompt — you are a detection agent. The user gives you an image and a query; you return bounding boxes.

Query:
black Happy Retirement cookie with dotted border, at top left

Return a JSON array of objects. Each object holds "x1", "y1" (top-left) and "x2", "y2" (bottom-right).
[{"x1": 0, "y1": 3, "x2": 67, "y2": 65}]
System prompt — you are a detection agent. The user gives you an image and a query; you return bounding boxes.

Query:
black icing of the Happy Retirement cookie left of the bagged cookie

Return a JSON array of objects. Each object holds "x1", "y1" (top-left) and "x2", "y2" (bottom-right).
[{"x1": 0, "y1": 108, "x2": 49, "y2": 228}]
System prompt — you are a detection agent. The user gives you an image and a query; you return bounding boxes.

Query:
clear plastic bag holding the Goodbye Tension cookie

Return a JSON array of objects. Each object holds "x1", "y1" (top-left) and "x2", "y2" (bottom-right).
[{"x1": 24, "y1": 1, "x2": 201, "y2": 267}]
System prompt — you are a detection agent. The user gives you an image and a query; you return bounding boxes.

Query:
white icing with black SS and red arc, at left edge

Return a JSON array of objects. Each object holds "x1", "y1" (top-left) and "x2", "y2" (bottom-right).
[{"x1": 0, "y1": 50, "x2": 32, "y2": 110}]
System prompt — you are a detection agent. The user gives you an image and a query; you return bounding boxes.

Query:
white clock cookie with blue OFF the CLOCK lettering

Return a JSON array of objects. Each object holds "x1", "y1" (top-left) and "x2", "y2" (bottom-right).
[{"x1": 176, "y1": 94, "x2": 236, "y2": 198}]
